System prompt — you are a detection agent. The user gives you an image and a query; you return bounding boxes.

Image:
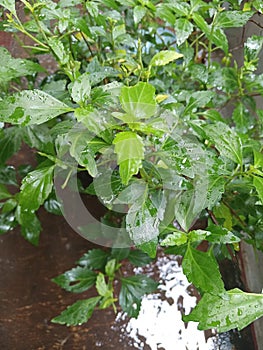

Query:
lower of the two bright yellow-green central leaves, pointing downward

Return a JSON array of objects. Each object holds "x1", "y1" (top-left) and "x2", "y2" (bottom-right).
[{"x1": 113, "y1": 131, "x2": 144, "y2": 185}]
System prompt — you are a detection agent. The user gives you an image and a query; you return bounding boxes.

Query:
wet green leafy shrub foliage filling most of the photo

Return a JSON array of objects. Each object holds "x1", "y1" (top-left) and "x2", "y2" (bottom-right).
[{"x1": 0, "y1": 0, "x2": 263, "y2": 332}]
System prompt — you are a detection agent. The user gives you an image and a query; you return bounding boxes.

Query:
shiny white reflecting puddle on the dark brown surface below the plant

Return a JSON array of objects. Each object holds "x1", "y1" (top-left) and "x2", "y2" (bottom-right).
[{"x1": 112, "y1": 256, "x2": 236, "y2": 350}]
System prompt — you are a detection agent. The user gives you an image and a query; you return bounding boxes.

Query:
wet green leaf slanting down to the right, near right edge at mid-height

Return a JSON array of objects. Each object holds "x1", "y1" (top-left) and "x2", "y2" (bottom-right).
[{"x1": 204, "y1": 122, "x2": 243, "y2": 165}]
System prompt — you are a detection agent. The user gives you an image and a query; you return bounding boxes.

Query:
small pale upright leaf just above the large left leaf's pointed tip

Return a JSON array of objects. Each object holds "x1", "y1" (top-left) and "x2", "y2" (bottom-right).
[{"x1": 69, "y1": 73, "x2": 91, "y2": 103}]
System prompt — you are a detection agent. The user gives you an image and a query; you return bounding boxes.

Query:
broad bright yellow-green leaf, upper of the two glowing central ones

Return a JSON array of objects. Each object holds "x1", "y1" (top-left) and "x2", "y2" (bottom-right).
[{"x1": 120, "y1": 82, "x2": 157, "y2": 122}]
